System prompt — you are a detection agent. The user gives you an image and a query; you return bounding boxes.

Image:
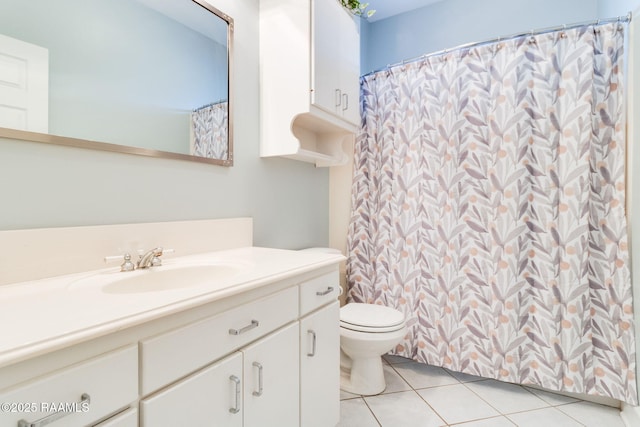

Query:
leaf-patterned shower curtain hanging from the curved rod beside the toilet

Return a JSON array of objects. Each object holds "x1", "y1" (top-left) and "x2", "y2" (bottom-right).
[{"x1": 347, "y1": 23, "x2": 637, "y2": 404}]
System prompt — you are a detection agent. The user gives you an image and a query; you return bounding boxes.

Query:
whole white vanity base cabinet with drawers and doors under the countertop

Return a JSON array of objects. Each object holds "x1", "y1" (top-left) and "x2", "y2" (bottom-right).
[{"x1": 0, "y1": 259, "x2": 339, "y2": 427}]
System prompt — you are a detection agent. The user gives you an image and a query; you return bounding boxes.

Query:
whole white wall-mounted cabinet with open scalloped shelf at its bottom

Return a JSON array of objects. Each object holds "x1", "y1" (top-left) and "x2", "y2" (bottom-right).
[{"x1": 260, "y1": 0, "x2": 360, "y2": 166}]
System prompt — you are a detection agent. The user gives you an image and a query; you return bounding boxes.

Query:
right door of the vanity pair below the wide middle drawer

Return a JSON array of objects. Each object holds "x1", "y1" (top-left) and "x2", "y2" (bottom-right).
[{"x1": 242, "y1": 322, "x2": 300, "y2": 427}]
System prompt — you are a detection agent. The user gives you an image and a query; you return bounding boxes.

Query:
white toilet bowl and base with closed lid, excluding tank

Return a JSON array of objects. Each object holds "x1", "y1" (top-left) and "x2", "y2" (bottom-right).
[{"x1": 340, "y1": 303, "x2": 407, "y2": 395}]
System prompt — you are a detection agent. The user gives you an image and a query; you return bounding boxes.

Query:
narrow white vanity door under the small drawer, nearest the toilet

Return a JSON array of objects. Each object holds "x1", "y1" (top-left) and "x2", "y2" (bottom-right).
[{"x1": 300, "y1": 301, "x2": 340, "y2": 427}]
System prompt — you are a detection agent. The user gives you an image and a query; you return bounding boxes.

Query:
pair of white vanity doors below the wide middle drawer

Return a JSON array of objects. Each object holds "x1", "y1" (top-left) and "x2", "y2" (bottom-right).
[{"x1": 140, "y1": 323, "x2": 299, "y2": 427}]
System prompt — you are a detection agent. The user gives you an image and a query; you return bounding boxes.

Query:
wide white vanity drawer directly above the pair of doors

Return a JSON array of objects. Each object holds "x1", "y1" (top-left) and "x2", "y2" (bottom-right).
[{"x1": 140, "y1": 286, "x2": 298, "y2": 395}]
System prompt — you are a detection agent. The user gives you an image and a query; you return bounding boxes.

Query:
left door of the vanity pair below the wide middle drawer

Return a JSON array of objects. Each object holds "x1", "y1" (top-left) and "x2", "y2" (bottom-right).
[{"x1": 140, "y1": 352, "x2": 243, "y2": 427}]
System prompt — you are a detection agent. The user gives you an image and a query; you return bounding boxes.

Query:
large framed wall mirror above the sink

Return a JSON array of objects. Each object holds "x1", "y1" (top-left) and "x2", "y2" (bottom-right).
[{"x1": 0, "y1": 0, "x2": 233, "y2": 166}]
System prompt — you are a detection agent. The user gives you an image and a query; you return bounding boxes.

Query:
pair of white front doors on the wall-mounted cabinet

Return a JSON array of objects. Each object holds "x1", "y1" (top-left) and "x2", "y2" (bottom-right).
[{"x1": 311, "y1": 0, "x2": 360, "y2": 125}]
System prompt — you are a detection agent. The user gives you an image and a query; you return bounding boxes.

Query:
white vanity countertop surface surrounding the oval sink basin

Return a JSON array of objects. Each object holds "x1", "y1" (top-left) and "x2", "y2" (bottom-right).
[{"x1": 0, "y1": 247, "x2": 344, "y2": 367}]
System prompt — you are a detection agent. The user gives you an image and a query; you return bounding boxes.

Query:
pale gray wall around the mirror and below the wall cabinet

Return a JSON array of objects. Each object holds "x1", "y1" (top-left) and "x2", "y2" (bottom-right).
[{"x1": 0, "y1": 0, "x2": 329, "y2": 249}]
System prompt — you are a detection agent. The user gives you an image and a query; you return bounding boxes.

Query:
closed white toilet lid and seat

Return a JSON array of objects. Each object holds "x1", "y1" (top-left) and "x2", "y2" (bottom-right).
[{"x1": 340, "y1": 303, "x2": 404, "y2": 332}]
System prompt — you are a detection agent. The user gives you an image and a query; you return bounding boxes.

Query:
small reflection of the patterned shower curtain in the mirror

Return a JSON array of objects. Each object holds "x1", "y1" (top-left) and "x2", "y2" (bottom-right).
[{"x1": 191, "y1": 101, "x2": 229, "y2": 160}]
